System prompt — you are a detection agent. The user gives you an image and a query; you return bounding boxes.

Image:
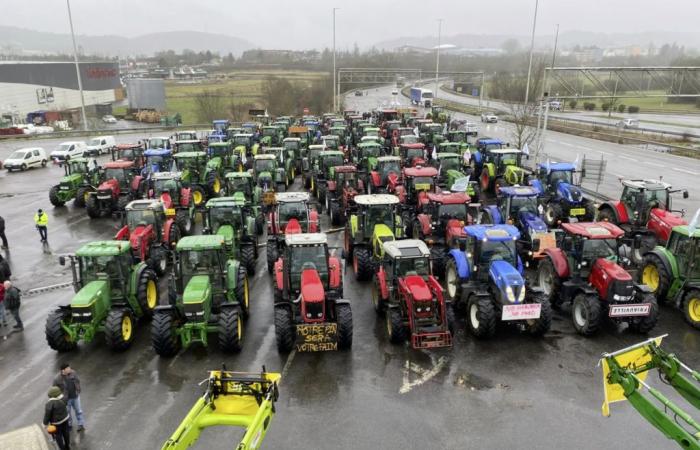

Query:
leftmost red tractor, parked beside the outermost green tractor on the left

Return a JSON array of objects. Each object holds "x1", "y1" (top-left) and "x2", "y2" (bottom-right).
[{"x1": 85, "y1": 161, "x2": 146, "y2": 219}]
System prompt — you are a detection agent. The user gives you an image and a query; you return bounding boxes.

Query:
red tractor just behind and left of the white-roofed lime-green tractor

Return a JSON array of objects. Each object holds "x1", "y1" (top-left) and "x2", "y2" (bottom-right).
[{"x1": 326, "y1": 166, "x2": 365, "y2": 225}]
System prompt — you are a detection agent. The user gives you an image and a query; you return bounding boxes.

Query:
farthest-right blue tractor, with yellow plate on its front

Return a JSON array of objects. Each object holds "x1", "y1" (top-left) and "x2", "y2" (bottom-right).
[{"x1": 530, "y1": 161, "x2": 596, "y2": 227}]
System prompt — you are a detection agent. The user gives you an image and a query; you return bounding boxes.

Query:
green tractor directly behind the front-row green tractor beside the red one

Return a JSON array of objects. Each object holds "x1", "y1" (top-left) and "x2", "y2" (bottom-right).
[{"x1": 204, "y1": 196, "x2": 258, "y2": 275}]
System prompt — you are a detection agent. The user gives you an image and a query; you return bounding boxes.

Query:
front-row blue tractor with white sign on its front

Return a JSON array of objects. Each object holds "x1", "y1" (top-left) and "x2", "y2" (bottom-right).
[{"x1": 445, "y1": 225, "x2": 552, "y2": 339}]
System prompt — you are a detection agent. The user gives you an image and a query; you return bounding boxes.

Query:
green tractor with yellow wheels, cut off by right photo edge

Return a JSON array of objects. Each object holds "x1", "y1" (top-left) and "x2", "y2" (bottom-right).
[{"x1": 637, "y1": 220, "x2": 700, "y2": 330}]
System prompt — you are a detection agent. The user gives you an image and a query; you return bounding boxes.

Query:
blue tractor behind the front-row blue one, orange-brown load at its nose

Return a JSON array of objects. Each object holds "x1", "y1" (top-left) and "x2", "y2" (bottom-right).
[{"x1": 480, "y1": 186, "x2": 557, "y2": 265}]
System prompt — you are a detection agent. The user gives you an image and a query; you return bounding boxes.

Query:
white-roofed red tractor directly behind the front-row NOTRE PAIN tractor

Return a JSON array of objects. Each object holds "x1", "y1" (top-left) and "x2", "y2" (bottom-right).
[{"x1": 267, "y1": 192, "x2": 320, "y2": 274}]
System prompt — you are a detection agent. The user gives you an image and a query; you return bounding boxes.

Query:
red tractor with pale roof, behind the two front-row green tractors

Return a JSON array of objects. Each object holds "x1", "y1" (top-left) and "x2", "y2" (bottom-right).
[{"x1": 114, "y1": 200, "x2": 180, "y2": 276}]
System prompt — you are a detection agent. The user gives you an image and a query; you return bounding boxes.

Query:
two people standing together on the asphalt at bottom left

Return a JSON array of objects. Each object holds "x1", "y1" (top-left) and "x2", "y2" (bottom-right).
[{"x1": 43, "y1": 363, "x2": 85, "y2": 450}]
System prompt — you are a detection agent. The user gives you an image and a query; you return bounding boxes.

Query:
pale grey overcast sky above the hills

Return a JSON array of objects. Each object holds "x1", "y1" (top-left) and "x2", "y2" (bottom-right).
[{"x1": 0, "y1": 0, "x2": 700, "y2": 49}]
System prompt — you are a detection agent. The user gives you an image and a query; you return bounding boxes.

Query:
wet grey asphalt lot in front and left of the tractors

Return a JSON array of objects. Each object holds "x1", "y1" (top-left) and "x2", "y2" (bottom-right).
[{"x1": 0, "y1": 131, "x2": 700, "y2": 449}]
